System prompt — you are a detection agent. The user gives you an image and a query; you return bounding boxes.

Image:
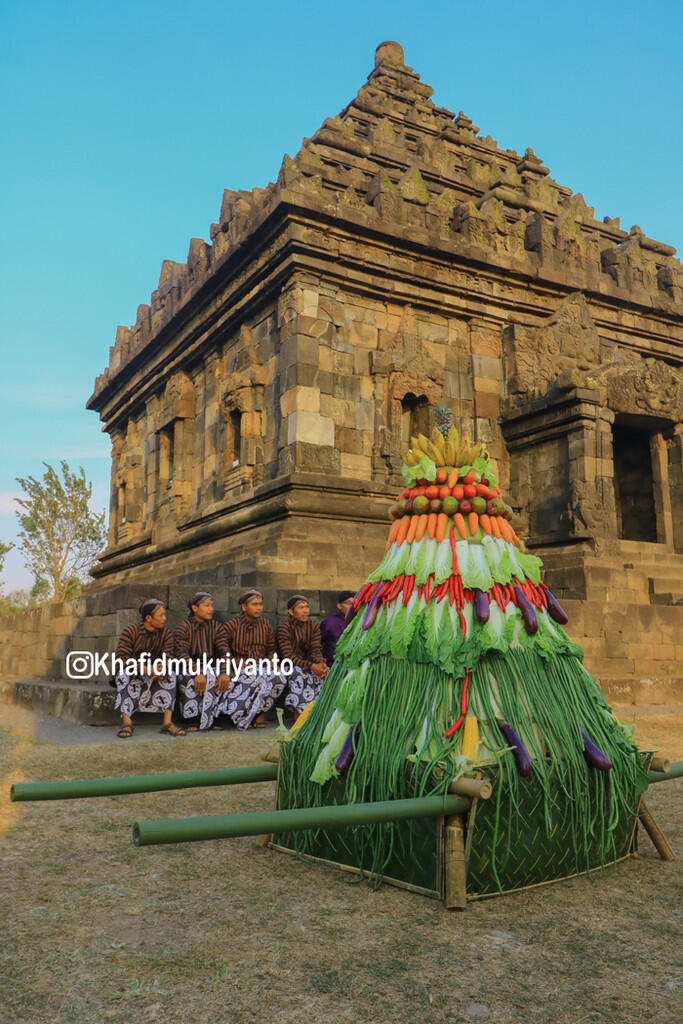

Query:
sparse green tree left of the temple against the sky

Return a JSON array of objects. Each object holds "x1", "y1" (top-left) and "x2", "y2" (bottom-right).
[{"x1": 16, "y1": 460, "x2": 104, "y2": 601}]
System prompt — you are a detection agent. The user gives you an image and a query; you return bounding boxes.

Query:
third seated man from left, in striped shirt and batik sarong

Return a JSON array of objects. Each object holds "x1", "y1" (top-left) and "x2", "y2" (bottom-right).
[{"x1": 225, "y1": 590, "x2": 287, "y2": 729}]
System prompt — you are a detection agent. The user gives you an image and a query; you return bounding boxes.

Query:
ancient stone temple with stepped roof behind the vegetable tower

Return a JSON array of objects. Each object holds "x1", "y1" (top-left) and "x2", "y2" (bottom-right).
[{"x1": 2, "y1": 42, "x2": 683, "y2": 701}]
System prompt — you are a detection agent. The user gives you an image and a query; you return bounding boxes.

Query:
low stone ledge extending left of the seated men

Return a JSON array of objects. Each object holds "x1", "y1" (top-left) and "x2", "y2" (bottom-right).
[{"x1": 0, "y1": 678, "x2": 118, "y2": 726}]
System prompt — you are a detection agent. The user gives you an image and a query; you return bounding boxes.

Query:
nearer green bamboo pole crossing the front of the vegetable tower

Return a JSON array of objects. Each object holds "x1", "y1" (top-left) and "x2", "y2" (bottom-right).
[{"x1": 133, "y1": 796, "x2": 470, "y2": 846}]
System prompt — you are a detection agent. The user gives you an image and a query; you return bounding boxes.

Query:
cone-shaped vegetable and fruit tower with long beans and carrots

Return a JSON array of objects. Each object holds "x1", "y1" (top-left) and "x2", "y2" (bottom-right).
[{"x1": 279, "y1": 415, "x2": 647, "y2": 895}]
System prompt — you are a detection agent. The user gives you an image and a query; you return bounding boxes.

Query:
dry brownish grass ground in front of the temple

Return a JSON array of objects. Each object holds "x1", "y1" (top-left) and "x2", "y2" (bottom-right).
[{"x1": 0, "y1": 715, "x2": 683, "y2": 1024}]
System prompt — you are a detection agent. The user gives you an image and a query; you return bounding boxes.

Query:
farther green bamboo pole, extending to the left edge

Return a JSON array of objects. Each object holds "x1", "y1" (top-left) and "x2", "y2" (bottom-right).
[{"x1": 9, "y1": 765, "x2": 278, "y2": 801}]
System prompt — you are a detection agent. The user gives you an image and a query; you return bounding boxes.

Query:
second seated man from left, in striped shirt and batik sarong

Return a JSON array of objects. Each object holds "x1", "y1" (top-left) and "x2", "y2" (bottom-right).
[{"x1": 173, "y1": 590, "x2": 230, "y2": 732}]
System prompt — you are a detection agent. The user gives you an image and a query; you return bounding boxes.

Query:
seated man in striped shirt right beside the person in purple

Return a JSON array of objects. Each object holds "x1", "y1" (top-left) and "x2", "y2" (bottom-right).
[{"x1": 276, "y1": 594, "x2": 329, "y2": 718}]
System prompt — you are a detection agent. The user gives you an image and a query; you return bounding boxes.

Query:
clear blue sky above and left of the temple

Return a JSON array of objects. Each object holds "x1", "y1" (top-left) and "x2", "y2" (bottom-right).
[{"x1": 0, "y1": 0, "x2": 683, "y2": 590}]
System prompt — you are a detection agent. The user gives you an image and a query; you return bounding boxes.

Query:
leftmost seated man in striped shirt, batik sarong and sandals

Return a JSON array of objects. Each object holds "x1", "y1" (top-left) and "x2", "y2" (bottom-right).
[{"x1": 116, "y1": 597, "x2": 185, "y2": 739}]
